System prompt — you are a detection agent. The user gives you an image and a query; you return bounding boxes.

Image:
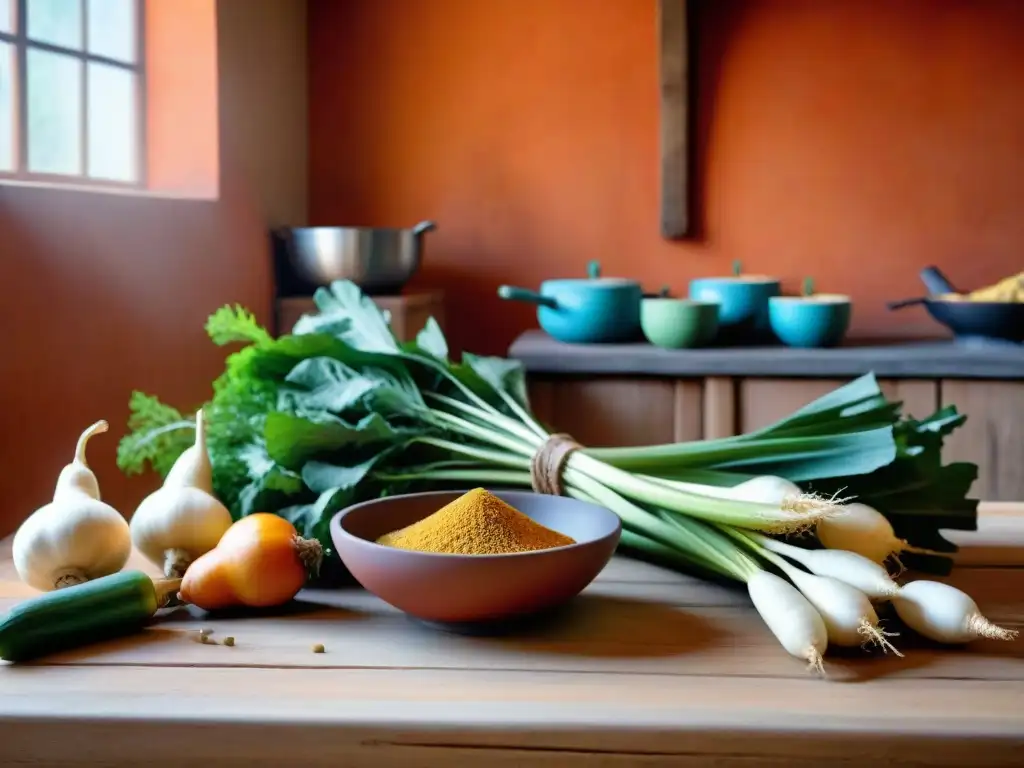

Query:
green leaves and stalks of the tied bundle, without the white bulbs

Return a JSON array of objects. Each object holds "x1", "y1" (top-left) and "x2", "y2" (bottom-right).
[{"x1": 118, "y1": 281, "x2": 977, "y2": 572}]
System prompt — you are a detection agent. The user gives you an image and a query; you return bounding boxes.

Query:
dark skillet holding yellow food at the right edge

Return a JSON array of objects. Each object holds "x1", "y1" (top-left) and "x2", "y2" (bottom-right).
[{"x1": 889, "y1": 266, "x2": 1024, "y2": 344}]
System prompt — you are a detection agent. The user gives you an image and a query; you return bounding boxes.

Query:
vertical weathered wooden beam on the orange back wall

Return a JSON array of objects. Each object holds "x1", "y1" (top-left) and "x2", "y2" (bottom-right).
[{"x1": 657, "y1": 0, "x2": 689, "y2": 240}]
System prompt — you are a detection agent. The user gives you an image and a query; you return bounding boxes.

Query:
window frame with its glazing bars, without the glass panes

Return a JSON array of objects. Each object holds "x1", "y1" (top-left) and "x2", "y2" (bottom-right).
[{"x1": 0, "y1": 0, "x2": 146, "y2": 188}]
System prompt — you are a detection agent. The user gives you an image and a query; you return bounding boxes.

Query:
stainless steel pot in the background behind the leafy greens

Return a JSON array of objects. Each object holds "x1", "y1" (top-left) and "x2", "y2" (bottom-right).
[{"x1": 276, "y1": 221, "x2": 436, "y2": 295}]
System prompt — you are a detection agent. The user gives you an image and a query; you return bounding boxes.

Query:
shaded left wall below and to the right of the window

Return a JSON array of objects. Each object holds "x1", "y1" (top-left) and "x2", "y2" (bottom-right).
[{"x1": 0, "y1": 0, "x2": 307, "y2": 537}]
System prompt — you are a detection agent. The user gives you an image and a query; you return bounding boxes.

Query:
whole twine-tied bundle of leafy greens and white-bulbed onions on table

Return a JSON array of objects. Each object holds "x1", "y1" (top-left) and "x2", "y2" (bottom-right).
[{"x1": 118, "y1": 282, "x2": 1011, "y2": 665}]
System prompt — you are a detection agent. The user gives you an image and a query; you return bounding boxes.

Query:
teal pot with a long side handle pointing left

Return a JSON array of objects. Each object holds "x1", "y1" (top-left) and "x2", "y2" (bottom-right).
[{"x1": 498, "y1": 262, "x2": 643, "y2": 344}]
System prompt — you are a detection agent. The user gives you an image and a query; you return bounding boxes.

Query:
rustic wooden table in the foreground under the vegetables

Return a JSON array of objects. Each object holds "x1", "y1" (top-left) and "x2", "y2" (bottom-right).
[{"x1": 0, "y1": 504, "x2": 1024, "y2": 768}]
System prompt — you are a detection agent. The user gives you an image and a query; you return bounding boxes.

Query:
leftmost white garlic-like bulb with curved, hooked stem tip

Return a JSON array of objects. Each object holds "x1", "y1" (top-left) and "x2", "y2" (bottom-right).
[{"x1": 12, "y1": 421, "x2": 131, "y2": 592}]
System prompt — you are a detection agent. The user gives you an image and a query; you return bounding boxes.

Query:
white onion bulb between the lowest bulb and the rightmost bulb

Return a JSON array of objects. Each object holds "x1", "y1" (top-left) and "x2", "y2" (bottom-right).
[{"x1": 770, "y1": 555, "x2": 903, "y2": 656}]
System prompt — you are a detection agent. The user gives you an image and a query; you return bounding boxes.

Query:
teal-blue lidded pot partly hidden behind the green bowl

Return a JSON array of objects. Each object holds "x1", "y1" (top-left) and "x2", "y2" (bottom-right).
[{"x1": 690, "y1": 274, "x2": 781, "y2": 341}]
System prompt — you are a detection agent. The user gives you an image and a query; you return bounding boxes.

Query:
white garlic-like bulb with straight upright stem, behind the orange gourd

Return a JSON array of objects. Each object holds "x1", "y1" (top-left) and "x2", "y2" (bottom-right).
[{"x1": 131, "y1": 411, "x2": 232, "y2": 579}]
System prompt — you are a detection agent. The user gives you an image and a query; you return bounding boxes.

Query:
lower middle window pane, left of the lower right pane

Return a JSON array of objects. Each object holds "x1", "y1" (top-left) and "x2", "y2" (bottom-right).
[{"x1": 26, "y1": 48, "x2": 82, "y2": 174}]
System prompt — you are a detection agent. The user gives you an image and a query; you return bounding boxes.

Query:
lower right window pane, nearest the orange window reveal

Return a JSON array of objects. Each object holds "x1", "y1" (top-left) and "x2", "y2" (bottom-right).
[{"x1": 87, "y1": 63, "x2": 138, "y2": 181}]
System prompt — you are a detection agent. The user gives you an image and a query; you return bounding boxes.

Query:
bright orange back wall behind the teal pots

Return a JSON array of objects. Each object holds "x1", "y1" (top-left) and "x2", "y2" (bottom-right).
[{"x1": 309, "y1": 0, "x2": 1024, "y2": 352}]
